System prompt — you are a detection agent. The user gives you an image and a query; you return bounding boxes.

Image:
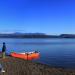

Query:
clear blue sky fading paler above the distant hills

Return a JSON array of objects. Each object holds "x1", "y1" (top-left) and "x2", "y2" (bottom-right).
[{"x1": 0, "y1": 0, "x2": 75, "y2": 34}]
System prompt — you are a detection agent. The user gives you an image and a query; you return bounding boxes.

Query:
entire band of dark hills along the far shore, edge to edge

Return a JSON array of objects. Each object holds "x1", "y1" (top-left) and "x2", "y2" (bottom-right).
[{"x1": 0, "y1": 32, "x2": 75, "y2": 38}]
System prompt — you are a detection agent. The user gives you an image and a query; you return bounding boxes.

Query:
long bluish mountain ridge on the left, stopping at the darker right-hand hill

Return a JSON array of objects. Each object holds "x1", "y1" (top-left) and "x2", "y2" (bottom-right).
[{"x1": 0, "y1": 32, "x2": 58, "y2": 38}]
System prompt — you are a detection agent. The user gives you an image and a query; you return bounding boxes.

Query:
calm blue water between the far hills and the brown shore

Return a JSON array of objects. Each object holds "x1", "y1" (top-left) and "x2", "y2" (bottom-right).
[{"x1": 0, "y1": 38, "x2": 75, "y2": 68}]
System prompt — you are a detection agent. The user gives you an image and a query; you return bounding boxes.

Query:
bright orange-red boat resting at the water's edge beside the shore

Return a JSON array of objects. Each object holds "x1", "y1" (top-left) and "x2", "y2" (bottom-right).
[{"x1": 10, "y1": 52, "x2": 40, "y2": 60}]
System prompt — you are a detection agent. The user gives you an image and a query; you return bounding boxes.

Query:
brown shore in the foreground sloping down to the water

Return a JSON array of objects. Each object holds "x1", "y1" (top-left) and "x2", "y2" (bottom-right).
[{"x1": 0, "y1": 56, "x2": 75, "y2": 75}]
